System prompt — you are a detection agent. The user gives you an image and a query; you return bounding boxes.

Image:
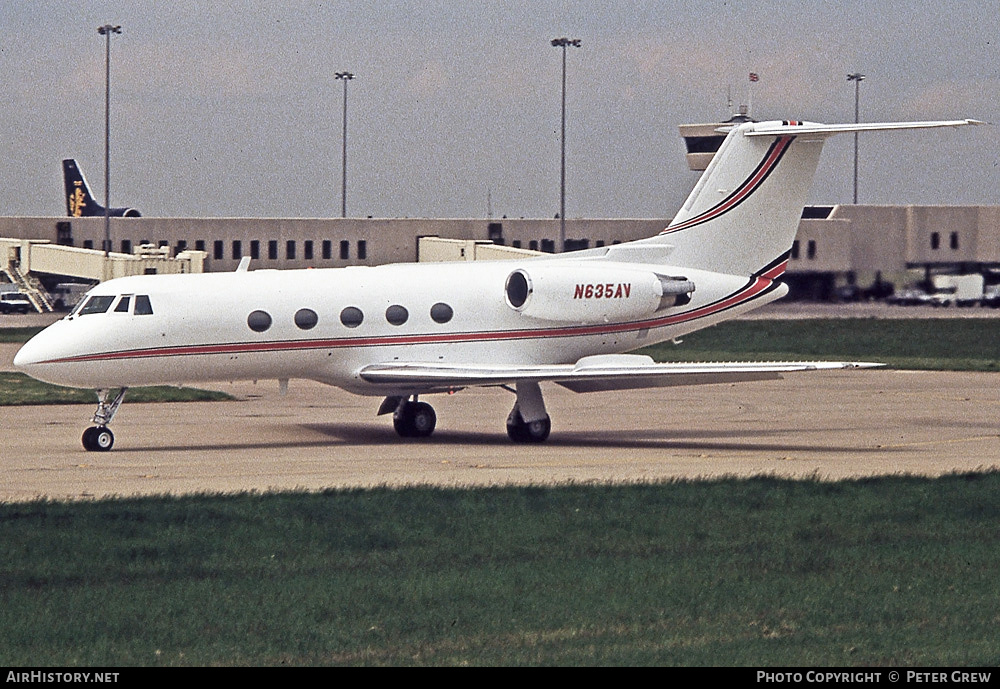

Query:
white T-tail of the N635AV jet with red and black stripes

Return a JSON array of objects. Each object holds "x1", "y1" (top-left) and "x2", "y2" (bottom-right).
[{"x1": 646, "y1": 120, "x2": 979, "y2": 278}]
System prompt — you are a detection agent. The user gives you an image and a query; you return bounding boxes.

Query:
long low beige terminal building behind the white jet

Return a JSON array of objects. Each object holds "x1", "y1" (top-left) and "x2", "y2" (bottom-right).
[{"x1": 0, "y1": 205, "x2": 1000, "y2": 299}]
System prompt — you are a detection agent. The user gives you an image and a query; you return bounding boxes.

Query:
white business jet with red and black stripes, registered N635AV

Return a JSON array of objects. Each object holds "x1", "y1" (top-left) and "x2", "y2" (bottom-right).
[{"x1": 14, "y1": 115, "x2": 976, "y2": 450}]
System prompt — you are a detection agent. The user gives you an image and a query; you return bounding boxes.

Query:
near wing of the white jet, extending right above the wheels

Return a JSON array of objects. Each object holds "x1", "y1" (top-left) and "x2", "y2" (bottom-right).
[{"x1": 359, "y1": 354, "x2": 882, "y2": 392}]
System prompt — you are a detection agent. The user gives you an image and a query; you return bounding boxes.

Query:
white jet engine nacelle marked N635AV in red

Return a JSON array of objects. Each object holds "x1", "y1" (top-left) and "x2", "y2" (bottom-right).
[{"x1": 505, "y1": 264, "x2": 694, "y2": 323}]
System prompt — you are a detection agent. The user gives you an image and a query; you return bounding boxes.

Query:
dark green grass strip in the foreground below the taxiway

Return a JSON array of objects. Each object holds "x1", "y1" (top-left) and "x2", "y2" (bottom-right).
[{"x1": 0, "y1": 474, "x2": 1000, "y2": 667}]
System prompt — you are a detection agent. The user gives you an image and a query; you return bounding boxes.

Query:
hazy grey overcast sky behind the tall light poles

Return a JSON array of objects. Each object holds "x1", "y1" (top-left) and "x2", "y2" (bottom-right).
[{"x1": 0, "y1": 0, "x2": 1000, "y2": 218}]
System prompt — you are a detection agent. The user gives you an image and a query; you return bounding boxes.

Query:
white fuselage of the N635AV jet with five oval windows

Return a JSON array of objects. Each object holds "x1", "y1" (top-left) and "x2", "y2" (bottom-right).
[{"x1": 11, "y1": 255, "x2": 784, "y2": 395}]
